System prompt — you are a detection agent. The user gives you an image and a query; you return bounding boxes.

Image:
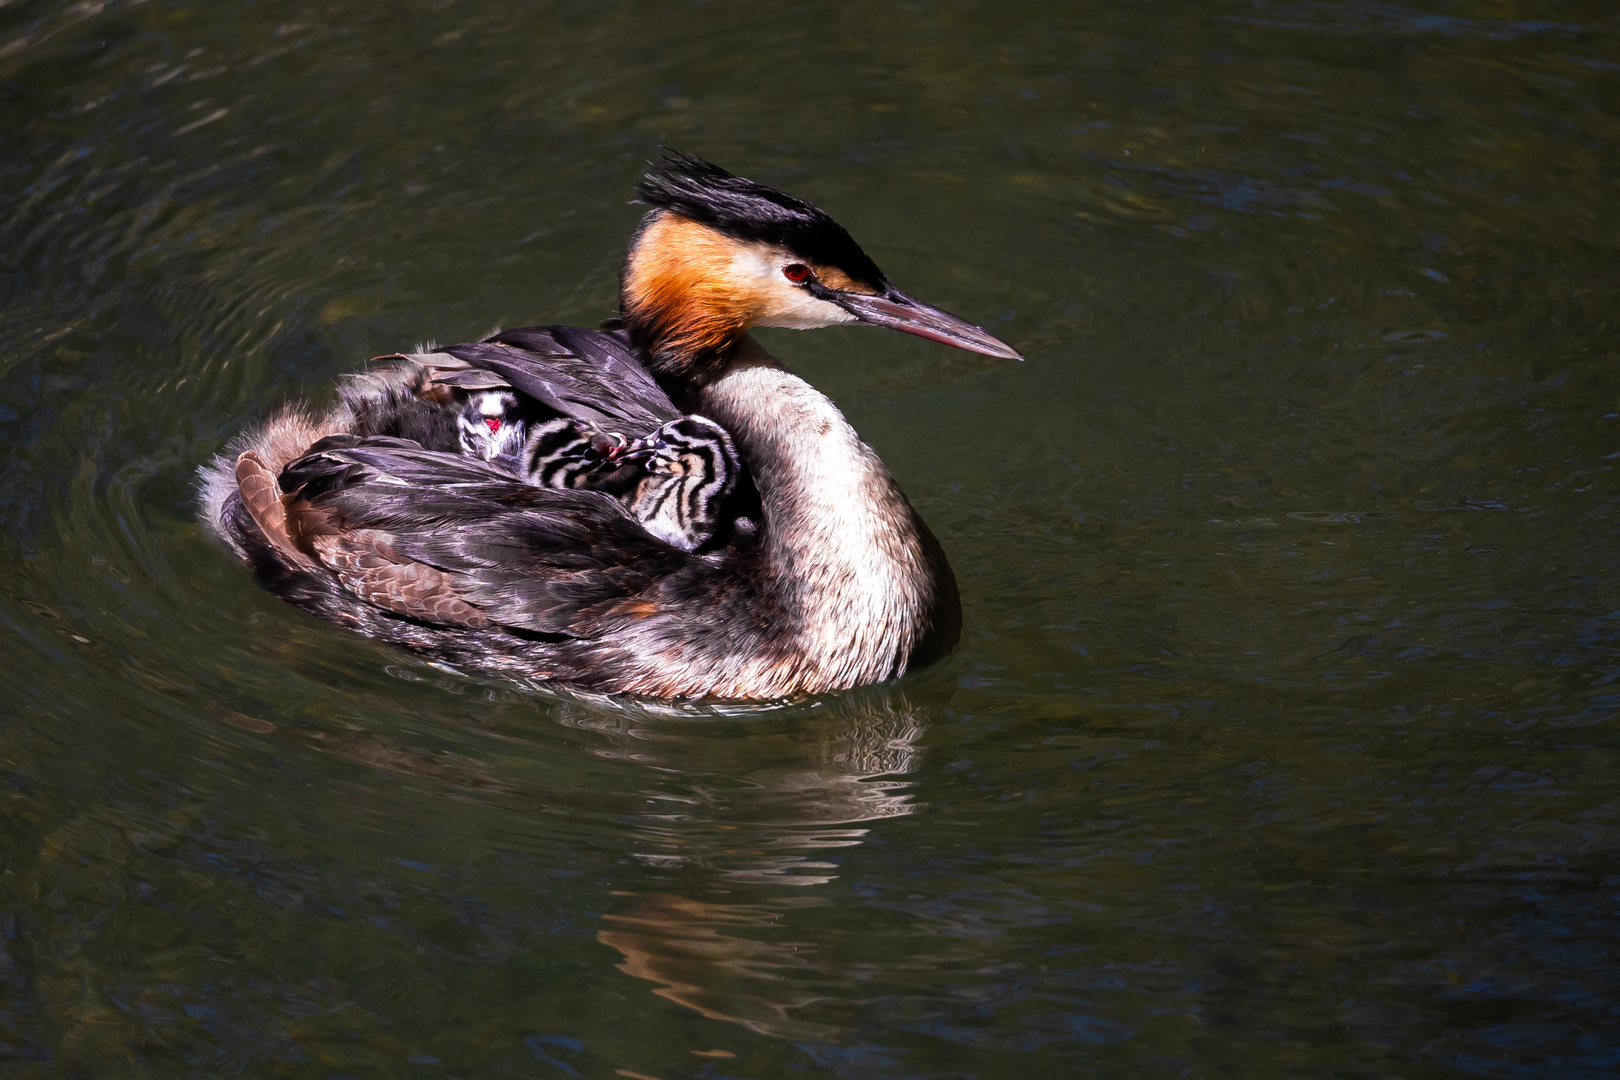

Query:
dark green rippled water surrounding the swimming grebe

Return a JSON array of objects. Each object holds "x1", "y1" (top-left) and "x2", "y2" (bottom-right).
[{"x1": 0, "y1": 0, "x2": 1620, "y2": 1080}]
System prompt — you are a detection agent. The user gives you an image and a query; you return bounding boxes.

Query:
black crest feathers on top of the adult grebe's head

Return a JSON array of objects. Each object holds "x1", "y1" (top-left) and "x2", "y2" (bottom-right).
[{"x1": 635, "y1": 151, "x2": 888, "y2": 291}]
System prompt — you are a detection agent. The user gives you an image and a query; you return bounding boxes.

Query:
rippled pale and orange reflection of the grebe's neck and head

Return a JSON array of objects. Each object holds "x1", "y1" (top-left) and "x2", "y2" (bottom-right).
[{"x1": 564, "y1": 691, "x2": 923, "y2": 1040}]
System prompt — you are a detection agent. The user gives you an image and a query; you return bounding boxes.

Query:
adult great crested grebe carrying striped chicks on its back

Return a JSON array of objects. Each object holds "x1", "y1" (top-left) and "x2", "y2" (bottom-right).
[{"x1": 203, "y1": 154, "x2": 1019, "y2": 699}]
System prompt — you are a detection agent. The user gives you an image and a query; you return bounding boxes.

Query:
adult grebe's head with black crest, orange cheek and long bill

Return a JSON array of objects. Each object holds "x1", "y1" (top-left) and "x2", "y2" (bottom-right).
[{"x1": 620, "y1": 154, "x2": 1022, "y2": 376}]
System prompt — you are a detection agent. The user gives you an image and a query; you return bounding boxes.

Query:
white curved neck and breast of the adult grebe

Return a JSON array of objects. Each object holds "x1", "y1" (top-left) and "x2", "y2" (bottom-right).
[{"x1": 697, "y1": 337, "x2": 957, "y2": 685}]
